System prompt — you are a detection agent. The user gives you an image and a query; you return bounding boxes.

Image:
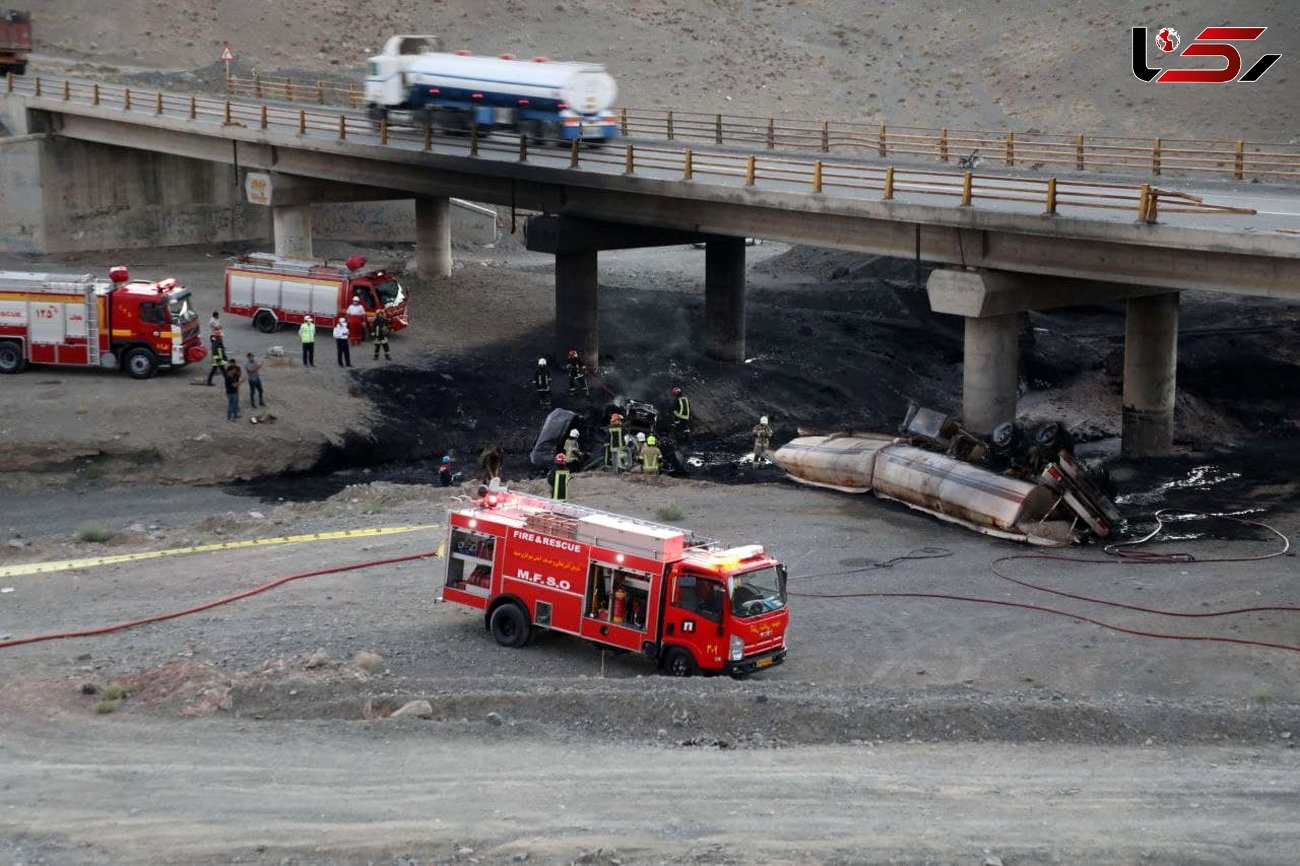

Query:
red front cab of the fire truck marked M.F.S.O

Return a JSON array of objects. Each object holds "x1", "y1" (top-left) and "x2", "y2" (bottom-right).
[{"x1": 659, "y1": 545, "x2": 789, "y2": 676}]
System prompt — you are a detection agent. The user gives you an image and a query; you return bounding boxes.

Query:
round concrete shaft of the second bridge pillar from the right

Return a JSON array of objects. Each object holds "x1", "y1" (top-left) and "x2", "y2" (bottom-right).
[{"x1": 962, "y1": 312, "x2": 1019, "y2": 436}]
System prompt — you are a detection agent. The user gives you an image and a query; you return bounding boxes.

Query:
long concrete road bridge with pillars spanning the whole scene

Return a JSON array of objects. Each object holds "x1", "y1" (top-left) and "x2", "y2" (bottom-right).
[{"x1": 0, "y1": 77, "x2": 1300, "y2": 456}]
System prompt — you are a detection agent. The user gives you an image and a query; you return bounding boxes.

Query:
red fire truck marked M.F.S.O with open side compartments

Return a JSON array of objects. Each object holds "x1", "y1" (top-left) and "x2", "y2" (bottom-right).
[{"x1": 442, "y1": 490, "x2": 789, "y2": 676}]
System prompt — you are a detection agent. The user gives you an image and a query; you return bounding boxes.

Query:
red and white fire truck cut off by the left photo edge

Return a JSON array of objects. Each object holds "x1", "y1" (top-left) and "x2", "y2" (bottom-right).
[{"x1": 0, "y1": 267, "x2": 208, "y2": 378}]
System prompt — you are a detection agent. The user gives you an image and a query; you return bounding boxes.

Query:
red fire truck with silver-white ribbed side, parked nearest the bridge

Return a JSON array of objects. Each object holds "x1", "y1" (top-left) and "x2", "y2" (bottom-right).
[{"x1": 226, "y1": 252, "x2": 411, "y2": 334}]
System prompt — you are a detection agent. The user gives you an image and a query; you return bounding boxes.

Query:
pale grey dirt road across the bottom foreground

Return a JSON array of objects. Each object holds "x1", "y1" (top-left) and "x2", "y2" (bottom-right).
[{"x1": 0, "y1": 718, "x2": 1300, "y2": 866}]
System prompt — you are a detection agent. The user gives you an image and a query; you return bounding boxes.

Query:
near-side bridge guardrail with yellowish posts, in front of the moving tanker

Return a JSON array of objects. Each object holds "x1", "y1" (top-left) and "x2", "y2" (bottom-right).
[{"x1": 5, "y1": 75, "x2": 1255, "y2": 222}]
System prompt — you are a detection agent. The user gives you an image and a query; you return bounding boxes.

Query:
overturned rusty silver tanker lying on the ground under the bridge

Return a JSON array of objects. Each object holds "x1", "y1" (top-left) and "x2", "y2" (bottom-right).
[{"x1": 774, "y1": 433, "x2": 1118, "y2": 546}]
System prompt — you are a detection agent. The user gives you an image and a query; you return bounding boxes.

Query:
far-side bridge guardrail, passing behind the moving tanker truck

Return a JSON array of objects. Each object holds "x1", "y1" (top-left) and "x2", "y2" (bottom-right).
[{"x1": 215, "y1": 75, "x2": 1300, "y2": 181}]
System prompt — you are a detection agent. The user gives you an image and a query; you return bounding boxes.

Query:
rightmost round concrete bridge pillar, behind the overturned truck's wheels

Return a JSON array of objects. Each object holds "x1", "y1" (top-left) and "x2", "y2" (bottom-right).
[{"x1": 1121, "y1": 291, "x2": 1178, "y2": 458}]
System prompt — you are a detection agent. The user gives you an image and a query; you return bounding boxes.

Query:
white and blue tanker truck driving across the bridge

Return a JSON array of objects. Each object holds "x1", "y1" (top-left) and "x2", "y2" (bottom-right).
[{"x1": 365, "y1": 35, "x2": 619, "y2": 143}]
